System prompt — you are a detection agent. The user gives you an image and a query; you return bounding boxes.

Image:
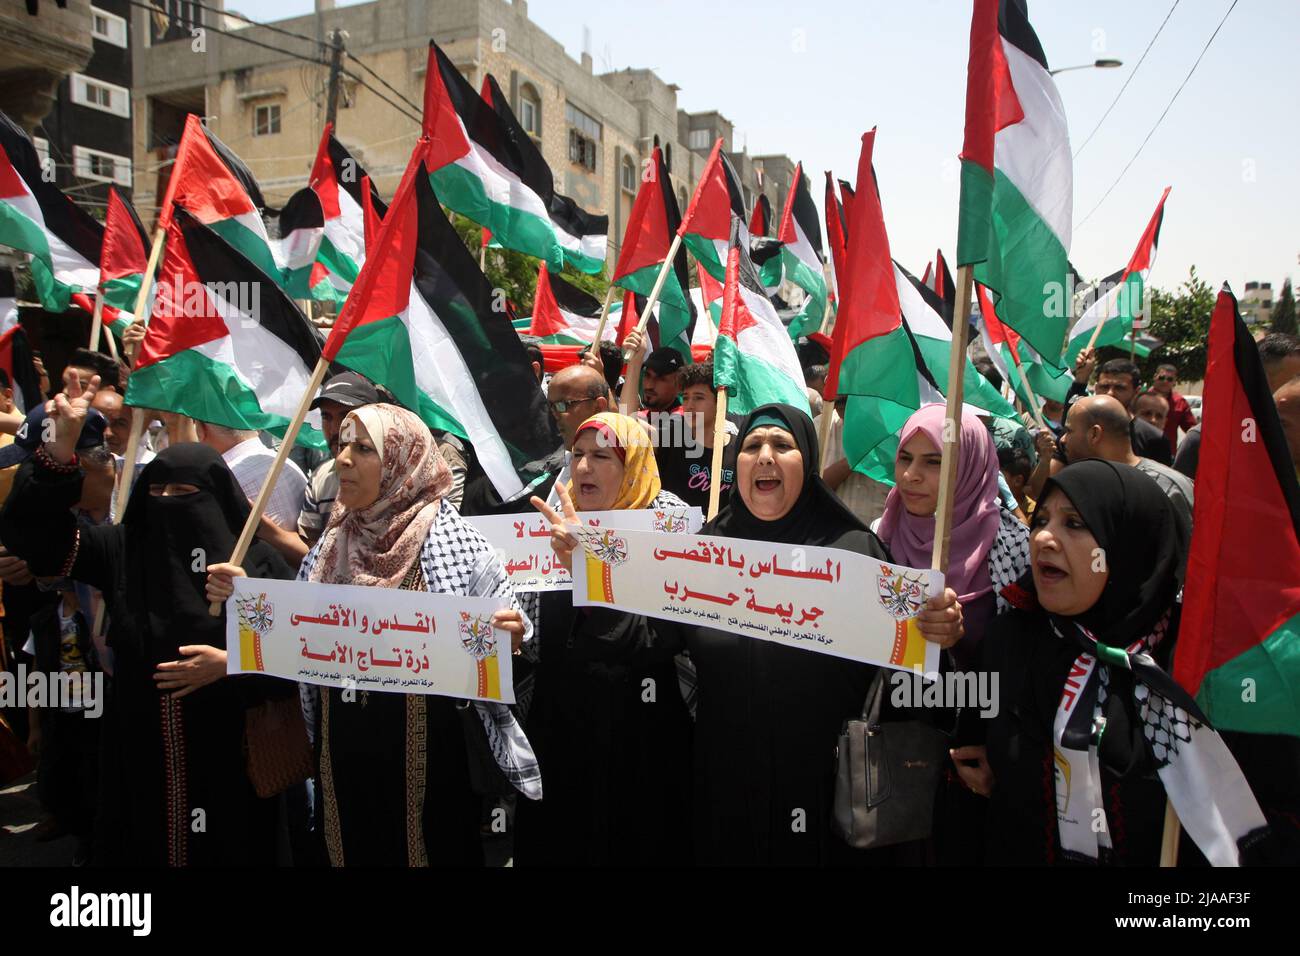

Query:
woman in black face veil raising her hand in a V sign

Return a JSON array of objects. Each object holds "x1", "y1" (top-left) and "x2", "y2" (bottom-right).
[{"x1": 0, "y1": 376, "x2": 296, "y2": 866}]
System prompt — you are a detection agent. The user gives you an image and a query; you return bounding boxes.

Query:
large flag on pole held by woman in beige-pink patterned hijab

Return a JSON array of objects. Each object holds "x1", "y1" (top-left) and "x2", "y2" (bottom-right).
[{"x1": 325, "y1": 149, "x2": 560, "y2": 501}]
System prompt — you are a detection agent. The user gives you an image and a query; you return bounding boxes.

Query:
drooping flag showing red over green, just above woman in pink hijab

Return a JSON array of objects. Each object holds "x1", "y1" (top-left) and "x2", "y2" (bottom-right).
[{"x1": 826, "y1": 130, "x2": 920, "y2": 483}]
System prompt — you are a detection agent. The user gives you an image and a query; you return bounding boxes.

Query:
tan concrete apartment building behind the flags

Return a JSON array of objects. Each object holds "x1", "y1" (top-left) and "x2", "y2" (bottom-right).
[{"x1": 131, "y1": 0, "x2": 794, "y2": 265}]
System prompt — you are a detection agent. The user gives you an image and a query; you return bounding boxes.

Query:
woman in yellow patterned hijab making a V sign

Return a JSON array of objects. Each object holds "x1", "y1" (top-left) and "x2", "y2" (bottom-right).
[{"x1": 515, "y1": 412, "x2": 690, "y2": 866}]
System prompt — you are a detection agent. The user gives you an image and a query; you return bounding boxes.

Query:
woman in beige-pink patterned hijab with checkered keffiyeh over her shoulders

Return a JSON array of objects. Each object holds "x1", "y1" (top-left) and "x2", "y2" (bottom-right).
[{"x1": 209, "y1": 403, "x2": 541, "y2": 866}]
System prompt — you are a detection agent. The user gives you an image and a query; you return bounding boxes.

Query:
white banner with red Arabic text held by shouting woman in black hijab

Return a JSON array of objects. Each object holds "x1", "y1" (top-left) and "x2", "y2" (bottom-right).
[{"x1": 573, "y1": 528, "x2": 944, "y2": 674}]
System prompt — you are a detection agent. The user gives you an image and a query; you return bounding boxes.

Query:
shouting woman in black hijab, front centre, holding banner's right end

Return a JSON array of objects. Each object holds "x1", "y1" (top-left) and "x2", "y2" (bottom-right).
[{"x1": 686, "y1": 405, "x2": 961, "y2": 866}]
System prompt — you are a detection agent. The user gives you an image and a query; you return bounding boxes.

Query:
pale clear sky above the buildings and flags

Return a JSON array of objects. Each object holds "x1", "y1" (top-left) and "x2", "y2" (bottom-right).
[{"x1": 248, "y1": 0, "x2": 1300, "y2": 293}]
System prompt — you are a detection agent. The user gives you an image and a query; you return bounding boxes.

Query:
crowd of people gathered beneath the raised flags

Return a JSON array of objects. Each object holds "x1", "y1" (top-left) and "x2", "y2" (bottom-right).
[{"x1": 0, "y1": 332, "x2": 1300, "y2": 866}]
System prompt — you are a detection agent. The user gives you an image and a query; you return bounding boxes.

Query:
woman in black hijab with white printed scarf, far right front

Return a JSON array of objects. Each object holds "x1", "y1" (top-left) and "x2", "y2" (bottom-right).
[{"x1": 957, "y1": 460, "x2": 1265, "y2": 865}]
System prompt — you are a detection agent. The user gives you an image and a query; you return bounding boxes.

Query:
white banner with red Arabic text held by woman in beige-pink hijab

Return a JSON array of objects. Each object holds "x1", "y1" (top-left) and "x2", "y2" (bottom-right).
[{"x1": 226, "y1": 578, "x2": 515, "y2": 704}]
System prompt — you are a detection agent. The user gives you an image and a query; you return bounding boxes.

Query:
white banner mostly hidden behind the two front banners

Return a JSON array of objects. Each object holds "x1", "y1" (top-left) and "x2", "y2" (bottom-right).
[{"x1": 467, "y1": 507, "x2": 705, "y2": 592}]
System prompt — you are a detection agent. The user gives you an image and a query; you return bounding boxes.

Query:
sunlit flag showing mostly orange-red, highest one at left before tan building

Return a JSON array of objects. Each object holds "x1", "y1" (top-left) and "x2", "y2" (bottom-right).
[{"x1": 159, "y1": 113, "x2": 283, "y2": 282}]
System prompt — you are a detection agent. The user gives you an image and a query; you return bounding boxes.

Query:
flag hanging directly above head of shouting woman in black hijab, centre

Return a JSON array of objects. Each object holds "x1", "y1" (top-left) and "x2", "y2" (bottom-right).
[{"x1": 714, "y1": 217, "x2": 811, "y2": 415}]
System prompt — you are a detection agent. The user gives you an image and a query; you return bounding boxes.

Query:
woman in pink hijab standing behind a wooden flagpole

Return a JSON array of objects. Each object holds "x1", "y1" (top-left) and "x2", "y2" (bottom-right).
[{"x1": 876, "y1": 405, "x2": 1030, "y2": 866}]
